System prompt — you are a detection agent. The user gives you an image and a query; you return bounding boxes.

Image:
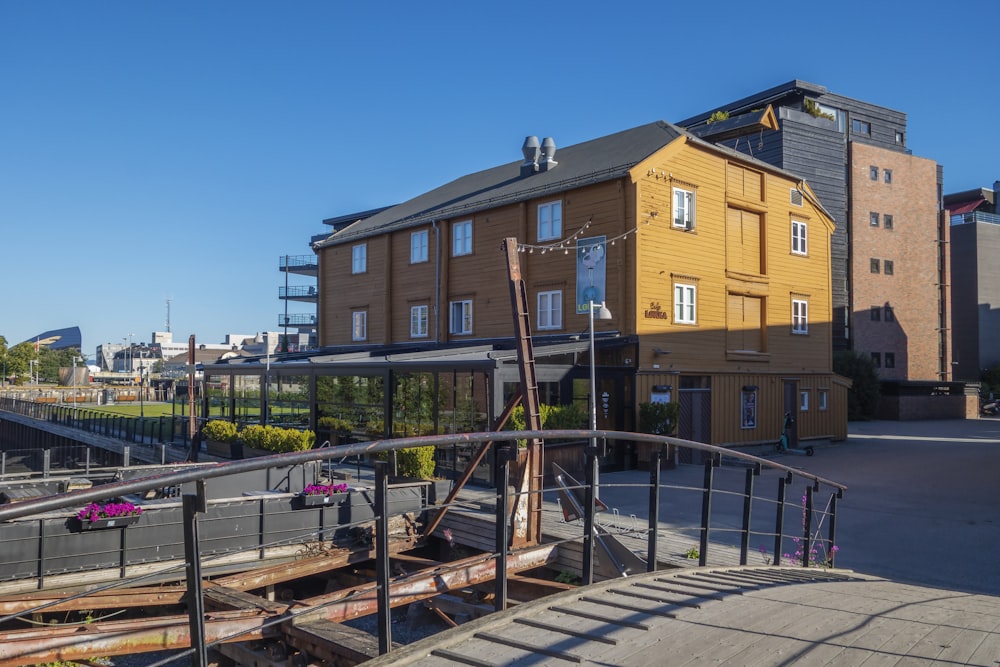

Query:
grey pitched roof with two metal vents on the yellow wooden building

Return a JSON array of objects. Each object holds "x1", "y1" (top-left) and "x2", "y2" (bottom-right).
[{"x1": 314, "y1": 121, "x2": 690, "y2": 248}]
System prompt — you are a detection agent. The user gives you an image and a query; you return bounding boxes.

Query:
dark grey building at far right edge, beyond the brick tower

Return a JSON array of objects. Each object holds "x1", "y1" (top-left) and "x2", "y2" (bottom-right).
[{"x1": 944, "y1": 181, "x2": 1000, "y2": 381}]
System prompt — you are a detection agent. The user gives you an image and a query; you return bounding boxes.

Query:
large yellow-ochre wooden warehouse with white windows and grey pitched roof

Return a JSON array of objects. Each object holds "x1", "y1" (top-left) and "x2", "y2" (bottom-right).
[{"x1": 314, "y1": 116, "x2": 847, "y2": 464}]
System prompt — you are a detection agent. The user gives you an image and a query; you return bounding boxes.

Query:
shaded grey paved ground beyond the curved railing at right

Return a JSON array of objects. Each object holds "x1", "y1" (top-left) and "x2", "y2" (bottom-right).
[{"x1": 601, "y1": 418, "x2": 1000, "y2": 595}]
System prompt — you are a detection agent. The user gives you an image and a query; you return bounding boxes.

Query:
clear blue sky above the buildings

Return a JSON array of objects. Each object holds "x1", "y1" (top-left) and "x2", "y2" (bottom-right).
[{"x1": 0, "y1": 0, "x2": 1000, "y2": 356}]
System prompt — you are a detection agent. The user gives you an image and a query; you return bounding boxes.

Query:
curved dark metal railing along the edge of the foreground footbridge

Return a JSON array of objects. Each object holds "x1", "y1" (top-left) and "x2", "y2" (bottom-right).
[{"x1": 0, "y1": 430, "x2": 846, "y2": 665}]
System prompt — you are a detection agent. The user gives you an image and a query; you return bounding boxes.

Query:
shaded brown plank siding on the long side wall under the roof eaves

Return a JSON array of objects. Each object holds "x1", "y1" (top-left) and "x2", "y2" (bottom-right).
[{"x1": 320, "y1": 181, "x2": 635, "y2": 345}]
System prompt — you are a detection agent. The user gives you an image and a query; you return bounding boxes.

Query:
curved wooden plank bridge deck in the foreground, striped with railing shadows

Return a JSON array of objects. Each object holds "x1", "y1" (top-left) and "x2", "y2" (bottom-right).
[{"x1": 364, "y1": 566, "x2": 1000, "y2": 667}]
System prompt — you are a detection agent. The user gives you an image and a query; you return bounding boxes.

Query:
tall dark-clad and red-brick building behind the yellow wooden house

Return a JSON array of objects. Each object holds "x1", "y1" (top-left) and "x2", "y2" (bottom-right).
[{"x1": 678, "y1": 80, "x2": 952, "y2": 382}]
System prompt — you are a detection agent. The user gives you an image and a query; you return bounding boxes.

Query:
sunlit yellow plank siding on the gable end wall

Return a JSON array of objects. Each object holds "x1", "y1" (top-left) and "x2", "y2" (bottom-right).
[{"x1": 633, "y1": 142, "x2": 832, "y2": 373}]
